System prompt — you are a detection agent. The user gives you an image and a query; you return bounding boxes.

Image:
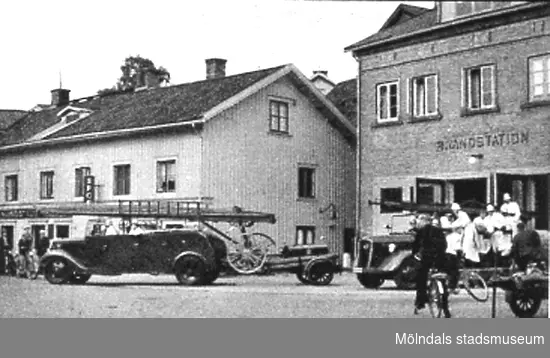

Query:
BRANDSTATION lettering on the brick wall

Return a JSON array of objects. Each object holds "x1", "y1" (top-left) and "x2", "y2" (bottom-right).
[{"x1": 435, "y1": 131, "x2": 529, "y2": 152}]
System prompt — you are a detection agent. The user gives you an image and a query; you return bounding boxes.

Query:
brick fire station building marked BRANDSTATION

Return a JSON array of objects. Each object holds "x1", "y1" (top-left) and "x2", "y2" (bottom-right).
[{"x1": 346, "y1": 1, "x2": 550, "y2": 242}]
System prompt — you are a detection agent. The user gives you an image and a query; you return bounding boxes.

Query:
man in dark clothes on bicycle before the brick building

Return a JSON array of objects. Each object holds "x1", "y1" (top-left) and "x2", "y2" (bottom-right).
[{"x1": 412, "y1": 214, "x2": 451, "y2": 318}]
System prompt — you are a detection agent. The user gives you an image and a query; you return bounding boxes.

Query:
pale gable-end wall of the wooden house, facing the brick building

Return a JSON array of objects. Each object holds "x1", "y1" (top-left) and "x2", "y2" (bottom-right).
[{"x1": 201, "y1": 75, "x2": 355, "y2": 252}]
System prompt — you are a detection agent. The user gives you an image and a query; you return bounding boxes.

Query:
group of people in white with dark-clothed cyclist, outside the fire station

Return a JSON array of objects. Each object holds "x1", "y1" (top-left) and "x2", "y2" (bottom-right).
[{"x1": 412, "y1": 193, "x2": 542, "y2": 317}]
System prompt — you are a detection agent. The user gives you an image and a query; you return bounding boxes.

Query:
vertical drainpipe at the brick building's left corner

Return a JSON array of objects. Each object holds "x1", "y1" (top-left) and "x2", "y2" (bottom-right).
[{"x1": 353, "y1": 54, "x2": 362, "y2": 262}]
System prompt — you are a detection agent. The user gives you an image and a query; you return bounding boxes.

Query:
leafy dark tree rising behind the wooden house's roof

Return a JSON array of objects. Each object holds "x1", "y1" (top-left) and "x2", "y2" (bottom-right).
[{"x1": 97, "y1": 55, "x2": 170, "y2": 95}]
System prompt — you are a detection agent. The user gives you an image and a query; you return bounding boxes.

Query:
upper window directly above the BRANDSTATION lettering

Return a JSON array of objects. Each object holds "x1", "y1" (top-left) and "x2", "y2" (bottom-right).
[{"x1": 465, "y1": 65, "x2": 496, "y2": 110}]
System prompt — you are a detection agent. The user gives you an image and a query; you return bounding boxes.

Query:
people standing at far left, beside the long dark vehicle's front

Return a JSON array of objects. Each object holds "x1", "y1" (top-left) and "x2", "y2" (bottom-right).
[{"x1": 0, "y1": 225, "x2": 51, "y2": 276}]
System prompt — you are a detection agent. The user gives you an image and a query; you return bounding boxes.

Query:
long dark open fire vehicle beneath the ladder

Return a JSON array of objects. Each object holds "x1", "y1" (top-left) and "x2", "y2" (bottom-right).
[{"x1": 40, "y1": 229, "x2": 227, "y2": 285}]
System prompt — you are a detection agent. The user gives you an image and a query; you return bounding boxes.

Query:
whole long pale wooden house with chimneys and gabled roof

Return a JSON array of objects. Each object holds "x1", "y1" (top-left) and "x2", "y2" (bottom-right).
[{"x1": 0, "y1": 59, "x2": 355, "y2": 252}]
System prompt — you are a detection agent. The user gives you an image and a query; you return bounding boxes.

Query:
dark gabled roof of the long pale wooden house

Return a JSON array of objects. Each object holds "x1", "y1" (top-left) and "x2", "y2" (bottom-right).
[{"x1": 0, "y1": 64, "x2": 355, "y2": 150}]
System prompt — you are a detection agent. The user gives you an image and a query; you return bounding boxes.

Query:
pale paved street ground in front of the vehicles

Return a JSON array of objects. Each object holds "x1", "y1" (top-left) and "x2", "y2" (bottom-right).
[{"x1": 0, "y1": 273, "x2": 548, "y2": 318}]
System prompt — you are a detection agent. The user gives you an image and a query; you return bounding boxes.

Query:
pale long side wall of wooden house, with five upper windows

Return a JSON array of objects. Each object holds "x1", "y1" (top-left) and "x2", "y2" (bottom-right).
[{"x1": 0, "y1": 134, "x2": 200, "y2": 205}]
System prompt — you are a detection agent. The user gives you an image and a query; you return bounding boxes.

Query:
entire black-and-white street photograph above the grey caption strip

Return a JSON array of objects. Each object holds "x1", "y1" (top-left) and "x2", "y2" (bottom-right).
[{"x1": 0, "y1": 0, "x2": 550, "y2": 321}]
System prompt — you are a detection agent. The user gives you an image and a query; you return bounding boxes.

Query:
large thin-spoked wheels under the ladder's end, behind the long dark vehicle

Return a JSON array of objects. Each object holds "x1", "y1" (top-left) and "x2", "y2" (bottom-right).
[{"x1": 227, "y1": 232, "x2": 275, "y2": 275}]
